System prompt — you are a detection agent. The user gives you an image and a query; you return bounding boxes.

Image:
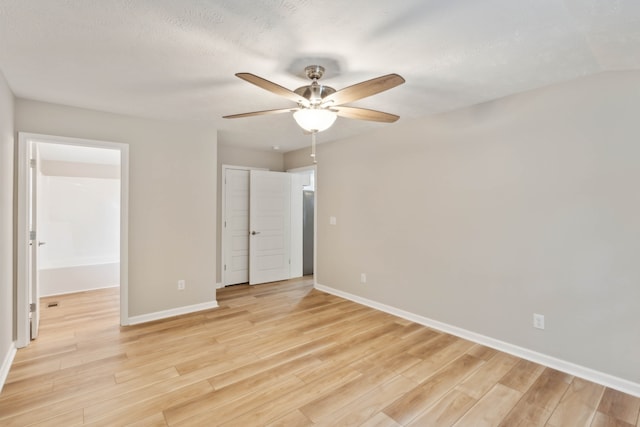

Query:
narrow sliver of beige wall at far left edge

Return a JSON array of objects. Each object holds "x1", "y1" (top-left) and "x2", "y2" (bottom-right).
[{"x1": 0, "y1": 72, "x2": 15, "y2": 389}]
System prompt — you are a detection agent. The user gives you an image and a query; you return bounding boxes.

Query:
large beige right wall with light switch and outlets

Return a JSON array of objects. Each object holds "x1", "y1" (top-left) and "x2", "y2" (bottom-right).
[{"x1": 285, "y1": 72, "x2": 640, "y2": 383}]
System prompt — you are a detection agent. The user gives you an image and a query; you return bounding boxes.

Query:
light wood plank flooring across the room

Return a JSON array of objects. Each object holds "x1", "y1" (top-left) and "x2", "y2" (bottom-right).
[{"x1": 0, "y1": 278, "x2": 640, "y2": 427}]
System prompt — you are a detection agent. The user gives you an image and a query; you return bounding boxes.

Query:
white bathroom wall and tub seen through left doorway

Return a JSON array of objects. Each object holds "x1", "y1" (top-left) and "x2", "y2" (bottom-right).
[{"x1": 38, "y1": 161, "x2": 120, "y2": 296}]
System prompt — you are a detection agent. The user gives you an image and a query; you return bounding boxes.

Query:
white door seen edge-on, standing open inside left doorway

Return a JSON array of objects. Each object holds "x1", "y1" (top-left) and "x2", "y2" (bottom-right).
[{"x1": 27, "y1": 142, "x2": 44, "y2": 340}]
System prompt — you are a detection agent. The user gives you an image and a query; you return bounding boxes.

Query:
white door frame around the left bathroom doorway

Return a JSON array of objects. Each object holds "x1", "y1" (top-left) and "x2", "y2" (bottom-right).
[{"x1": 16, "y1": 132, "x2": 129, "y2": 348}]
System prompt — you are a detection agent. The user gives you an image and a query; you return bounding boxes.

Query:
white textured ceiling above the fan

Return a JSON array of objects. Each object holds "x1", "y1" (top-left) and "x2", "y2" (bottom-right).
[{"x1": 0, "y1": 0, "x2": 640, "y2": 151}]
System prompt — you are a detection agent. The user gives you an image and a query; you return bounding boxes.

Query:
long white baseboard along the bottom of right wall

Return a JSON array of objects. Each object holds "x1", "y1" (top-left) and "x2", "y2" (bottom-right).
[{"x1": 315, "y1": 282, "x2": 640, "y2": 397}]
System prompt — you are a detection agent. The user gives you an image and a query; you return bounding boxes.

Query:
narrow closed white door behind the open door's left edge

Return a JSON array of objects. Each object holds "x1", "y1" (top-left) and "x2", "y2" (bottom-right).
[{"x1": 223, "y1": 169, "x2": 249, "y2": 286}]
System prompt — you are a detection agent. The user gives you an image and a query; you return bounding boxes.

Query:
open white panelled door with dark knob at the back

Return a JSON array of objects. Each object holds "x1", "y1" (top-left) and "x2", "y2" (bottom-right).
[{"x1": 249, "y1": 170, "x2": 291, "y2": 285}]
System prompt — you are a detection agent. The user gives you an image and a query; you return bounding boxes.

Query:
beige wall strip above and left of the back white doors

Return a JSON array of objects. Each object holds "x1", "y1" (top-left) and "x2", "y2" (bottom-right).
[{"x1": 216, "y1": 143, "x2": 284, "y2": 283}]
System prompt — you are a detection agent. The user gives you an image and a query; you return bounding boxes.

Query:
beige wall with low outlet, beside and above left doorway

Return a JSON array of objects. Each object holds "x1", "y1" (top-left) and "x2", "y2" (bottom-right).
[{"x1": 16, "y1": 99, "x2": 217, "y2": 317}]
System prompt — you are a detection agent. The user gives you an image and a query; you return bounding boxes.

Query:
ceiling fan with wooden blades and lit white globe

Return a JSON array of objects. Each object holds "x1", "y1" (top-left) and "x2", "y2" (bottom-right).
[{"x1": 223, "y1": 65, "x2": 405, "y2": 134}]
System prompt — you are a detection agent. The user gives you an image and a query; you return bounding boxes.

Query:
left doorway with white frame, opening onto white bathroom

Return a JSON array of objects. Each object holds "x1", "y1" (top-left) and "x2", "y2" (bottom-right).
[{"x1": 17, "y1": 133, "x2": 128, "y2": 347}]
